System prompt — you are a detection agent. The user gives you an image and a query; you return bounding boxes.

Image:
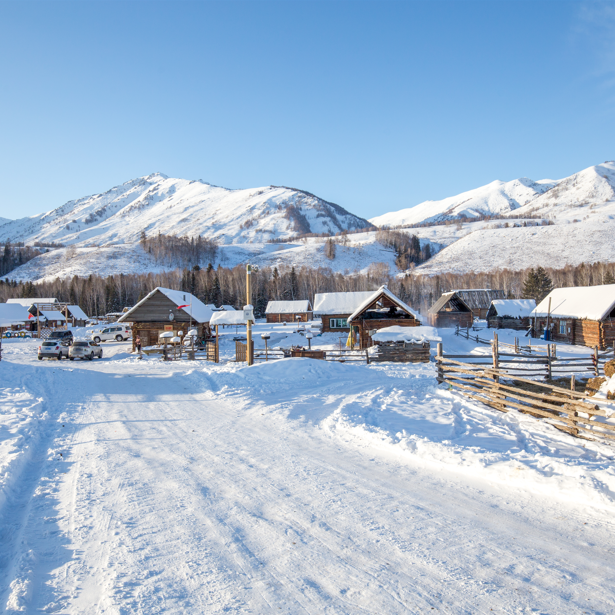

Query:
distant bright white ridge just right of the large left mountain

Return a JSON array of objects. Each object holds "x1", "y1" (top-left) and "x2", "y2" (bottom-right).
[{"x1": 370, "y1": 177, "x2": 557, "y2": 227}]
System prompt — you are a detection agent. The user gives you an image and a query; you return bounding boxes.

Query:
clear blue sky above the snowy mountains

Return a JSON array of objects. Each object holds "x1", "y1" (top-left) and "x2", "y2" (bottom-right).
[{"x1": 0, "y1": 0, "x2": 615, "y2": 218}]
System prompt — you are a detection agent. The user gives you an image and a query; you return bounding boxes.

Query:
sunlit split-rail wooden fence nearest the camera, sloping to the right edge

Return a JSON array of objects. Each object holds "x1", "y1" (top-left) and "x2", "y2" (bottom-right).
[{"x1": 436, "y1": 352, "x2": 615, "y2": 440}]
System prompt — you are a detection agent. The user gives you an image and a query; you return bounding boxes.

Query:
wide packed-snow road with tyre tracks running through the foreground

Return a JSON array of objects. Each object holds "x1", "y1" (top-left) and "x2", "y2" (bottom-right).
[{"x1": 0, "y1": 340, "x2": 615, "y2": 614}]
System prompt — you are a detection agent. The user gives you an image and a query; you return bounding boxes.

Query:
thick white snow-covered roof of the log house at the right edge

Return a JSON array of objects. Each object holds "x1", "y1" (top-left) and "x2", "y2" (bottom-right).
[{"x1": 531, "y1": 284, "x2": 615, "y2": 320}]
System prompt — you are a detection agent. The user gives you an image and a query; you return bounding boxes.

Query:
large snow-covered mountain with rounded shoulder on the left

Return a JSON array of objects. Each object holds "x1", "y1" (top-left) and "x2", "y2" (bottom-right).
[{"x1": 0, "y1": 173, "x2": 371, "y2": 246}]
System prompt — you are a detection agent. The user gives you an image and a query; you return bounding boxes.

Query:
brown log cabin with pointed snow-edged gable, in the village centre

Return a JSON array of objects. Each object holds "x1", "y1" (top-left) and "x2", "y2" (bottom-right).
[{"x1": 347, "y1": 286, "x2": 421, "y2": 348}]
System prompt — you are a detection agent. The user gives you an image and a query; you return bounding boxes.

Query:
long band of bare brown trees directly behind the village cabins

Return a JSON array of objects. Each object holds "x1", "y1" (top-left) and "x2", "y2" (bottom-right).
[{"x1": 0, "y1": 263, "x2": 615, "y2": 317}]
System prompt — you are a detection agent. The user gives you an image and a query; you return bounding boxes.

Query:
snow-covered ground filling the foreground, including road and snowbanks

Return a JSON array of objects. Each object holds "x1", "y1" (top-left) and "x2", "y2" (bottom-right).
[{"x1": 0, "y1": 325, "x2": 615, "y2": 615}]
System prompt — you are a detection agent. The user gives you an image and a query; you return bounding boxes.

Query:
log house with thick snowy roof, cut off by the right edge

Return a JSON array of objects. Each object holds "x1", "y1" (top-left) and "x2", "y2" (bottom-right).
[{"x1": 531, "y1": 284, "x2": 615, "y2": 350}]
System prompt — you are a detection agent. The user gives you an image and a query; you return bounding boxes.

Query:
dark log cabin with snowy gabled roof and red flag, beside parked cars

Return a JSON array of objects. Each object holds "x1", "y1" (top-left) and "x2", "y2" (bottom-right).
[{"x1": 118, "y1": 287, "x2": 213, "y2": 352}]
